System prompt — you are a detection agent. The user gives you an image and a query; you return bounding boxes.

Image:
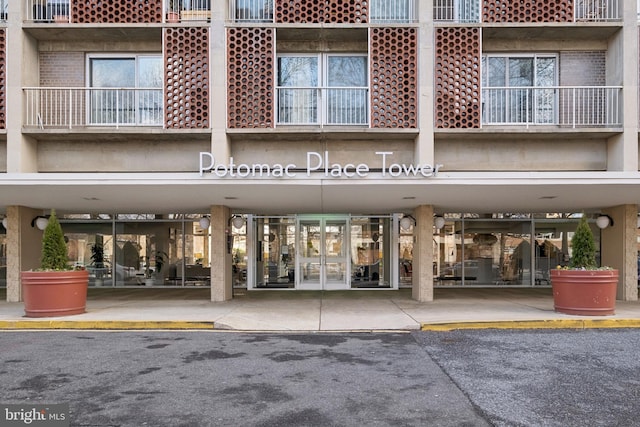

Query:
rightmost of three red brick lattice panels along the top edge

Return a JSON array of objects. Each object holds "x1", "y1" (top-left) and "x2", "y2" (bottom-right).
[{"x1": 482, "y1": 0, "x2": 574, "y2": 22}]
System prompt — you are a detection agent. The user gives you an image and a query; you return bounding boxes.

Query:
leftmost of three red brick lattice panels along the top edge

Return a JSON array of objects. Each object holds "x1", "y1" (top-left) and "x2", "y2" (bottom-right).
[{"x1": 71, "y1": 0, "x2": 162, "y2": 24}]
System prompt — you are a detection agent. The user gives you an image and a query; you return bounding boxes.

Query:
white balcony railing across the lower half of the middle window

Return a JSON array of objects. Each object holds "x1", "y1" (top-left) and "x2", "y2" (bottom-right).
[{"x1": 276, "y1": 87, "x2": 369, "y2": 126}]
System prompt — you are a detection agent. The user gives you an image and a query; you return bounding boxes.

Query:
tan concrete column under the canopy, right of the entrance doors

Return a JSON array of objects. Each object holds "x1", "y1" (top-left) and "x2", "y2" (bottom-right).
[{"x1": 411, "y1": 206, "x2": 433, "y2": 302}]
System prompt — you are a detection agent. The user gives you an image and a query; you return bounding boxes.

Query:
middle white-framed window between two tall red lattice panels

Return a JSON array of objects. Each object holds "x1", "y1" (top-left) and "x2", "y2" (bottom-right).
[{"x1": 277, "y1": 54, "x2": 369, "y2": 125}]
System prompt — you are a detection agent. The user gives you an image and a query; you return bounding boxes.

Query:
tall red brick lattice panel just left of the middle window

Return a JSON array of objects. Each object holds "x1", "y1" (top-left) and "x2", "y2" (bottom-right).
[{"x1": 227, "y1": 28, "x2": 275, "y2": 128}]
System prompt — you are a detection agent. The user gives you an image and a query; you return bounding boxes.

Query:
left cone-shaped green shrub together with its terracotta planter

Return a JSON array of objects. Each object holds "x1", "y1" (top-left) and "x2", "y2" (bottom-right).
[{"x1": 21, "y1": 211, "x2": 89, "y2": 317}]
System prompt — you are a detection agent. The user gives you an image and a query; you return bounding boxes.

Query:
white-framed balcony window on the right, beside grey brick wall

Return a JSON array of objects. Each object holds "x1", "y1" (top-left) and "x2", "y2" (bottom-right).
[{"x1": 482, "y1": 55, "x2": 557, "y2": 124}]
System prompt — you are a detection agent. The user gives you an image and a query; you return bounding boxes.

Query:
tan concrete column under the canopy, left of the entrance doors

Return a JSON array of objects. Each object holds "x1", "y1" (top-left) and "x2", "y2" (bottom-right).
[{"x1": 210, "y1": 206, "x2": 233, "y2": 302}]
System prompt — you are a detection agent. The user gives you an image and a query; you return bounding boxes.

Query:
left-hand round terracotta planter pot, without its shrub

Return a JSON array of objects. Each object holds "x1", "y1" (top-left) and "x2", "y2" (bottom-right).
[{"x1": 22, "y1": 270, "x2": 89, "y2": 317}]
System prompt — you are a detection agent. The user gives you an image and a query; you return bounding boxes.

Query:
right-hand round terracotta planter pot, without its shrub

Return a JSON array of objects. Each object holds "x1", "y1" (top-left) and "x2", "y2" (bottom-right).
[{"x1": 551, "y1": 270, "x2": 618, "y2": 316}]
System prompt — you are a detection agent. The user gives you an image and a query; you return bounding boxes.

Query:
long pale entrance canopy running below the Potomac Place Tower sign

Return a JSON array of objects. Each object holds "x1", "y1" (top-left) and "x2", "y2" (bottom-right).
[{"x1": 0, "y1": 170, "x2": 640, "y2": 214}]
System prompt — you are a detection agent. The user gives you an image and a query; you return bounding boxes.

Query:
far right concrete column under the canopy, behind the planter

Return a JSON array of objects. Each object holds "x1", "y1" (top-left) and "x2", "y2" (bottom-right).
[{"x1": 600, "y1": 205, "x2": 638, "y2": 301}]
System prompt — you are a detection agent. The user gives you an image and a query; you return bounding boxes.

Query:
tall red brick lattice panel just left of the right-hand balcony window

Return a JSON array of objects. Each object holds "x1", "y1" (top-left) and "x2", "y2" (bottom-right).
[{"x1": 435, "y1": 27, "x2": 481, "y2": 129}]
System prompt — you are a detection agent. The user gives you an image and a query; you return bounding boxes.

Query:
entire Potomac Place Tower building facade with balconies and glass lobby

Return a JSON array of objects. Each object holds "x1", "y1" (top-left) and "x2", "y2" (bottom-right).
[{"x1": 0, "y1": 0, "x2": 640, "y2": 301}]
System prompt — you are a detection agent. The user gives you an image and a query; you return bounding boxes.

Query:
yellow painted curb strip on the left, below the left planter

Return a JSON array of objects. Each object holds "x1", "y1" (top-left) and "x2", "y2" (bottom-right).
[{"x1": 0, "y1": 320, "x2": 214, "y2": 330}]
